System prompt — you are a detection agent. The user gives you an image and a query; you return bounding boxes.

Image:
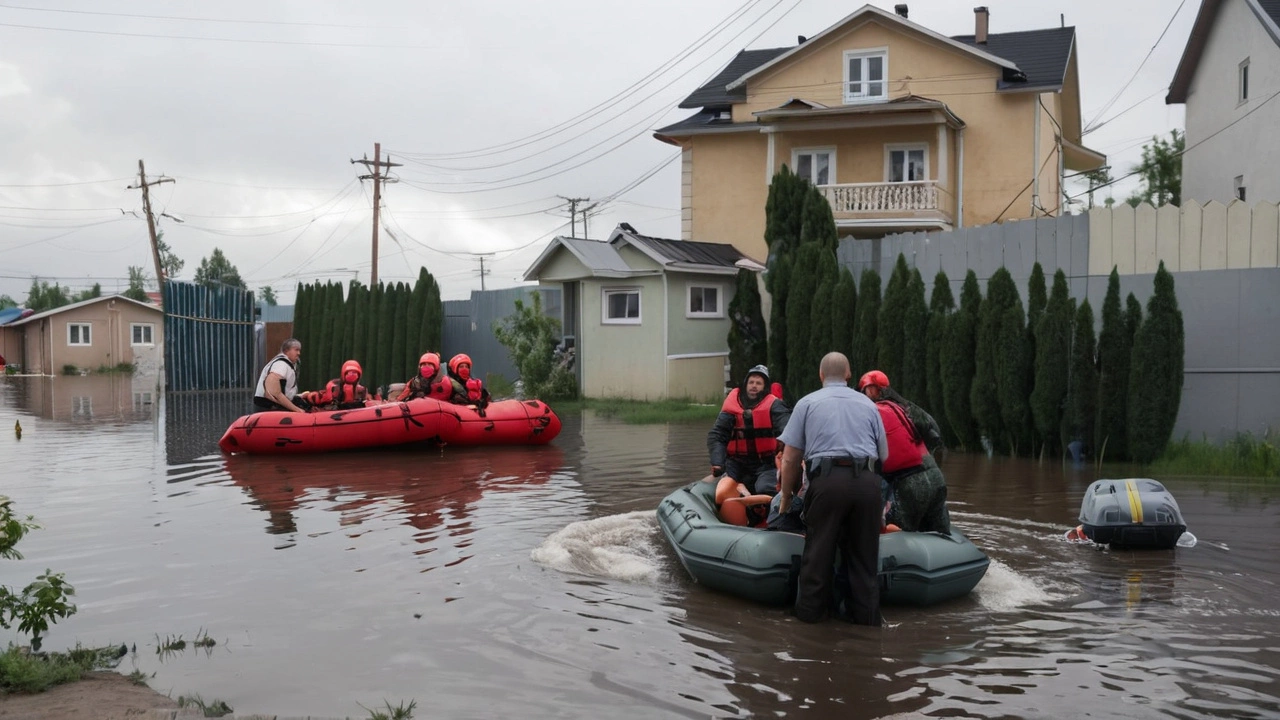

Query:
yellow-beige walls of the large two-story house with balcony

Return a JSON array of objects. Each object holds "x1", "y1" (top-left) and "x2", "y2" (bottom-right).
[{"x1": 680, "y1": 14, "x2": 1079, "y2": 261}]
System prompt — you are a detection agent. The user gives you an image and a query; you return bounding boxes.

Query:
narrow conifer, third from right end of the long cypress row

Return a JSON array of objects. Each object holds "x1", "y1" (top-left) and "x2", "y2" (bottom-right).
[{"x1": 1093, "y1": 268, "x2": 1132, "y2": 459}]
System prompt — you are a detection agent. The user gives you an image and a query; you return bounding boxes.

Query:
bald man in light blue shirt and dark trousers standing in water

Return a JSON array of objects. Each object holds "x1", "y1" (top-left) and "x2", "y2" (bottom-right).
[{"x1": 778, "y1": 352, "x2": 888, "y2": 625}]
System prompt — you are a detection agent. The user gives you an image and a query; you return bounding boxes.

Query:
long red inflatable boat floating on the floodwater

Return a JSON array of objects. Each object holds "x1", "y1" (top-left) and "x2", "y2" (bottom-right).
[{"x1": 218, "y1": 398, "x2": 561, "y2": 454}]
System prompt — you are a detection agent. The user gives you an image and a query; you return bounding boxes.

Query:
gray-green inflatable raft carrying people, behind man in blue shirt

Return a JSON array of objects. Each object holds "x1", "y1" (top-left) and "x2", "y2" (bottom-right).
[{"x1": 658, "y1": 482, "x2": 989, "y2": 606}]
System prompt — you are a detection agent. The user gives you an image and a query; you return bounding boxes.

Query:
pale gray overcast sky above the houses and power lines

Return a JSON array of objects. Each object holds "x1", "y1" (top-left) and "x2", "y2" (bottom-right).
[{"x1": 0, "y1": 0, "x2": 1199, "y2": 304}]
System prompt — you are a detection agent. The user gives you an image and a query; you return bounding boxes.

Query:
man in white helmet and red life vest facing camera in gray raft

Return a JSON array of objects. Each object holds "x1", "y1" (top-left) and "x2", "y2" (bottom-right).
[{"x1": 707, "y1": 365, "x2": 791, "y2": 496}]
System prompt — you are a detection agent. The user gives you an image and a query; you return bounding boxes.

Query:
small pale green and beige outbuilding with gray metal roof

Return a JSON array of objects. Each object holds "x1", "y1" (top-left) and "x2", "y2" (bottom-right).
[{"x1": 525, "y1": 223, "x2": 764, "y2": 401}]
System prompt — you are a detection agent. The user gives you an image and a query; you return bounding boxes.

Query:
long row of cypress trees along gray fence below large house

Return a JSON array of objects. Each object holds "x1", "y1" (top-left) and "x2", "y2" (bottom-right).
[{"x1": 728, "y1": 167, "x2": 1184, "y2": 461}]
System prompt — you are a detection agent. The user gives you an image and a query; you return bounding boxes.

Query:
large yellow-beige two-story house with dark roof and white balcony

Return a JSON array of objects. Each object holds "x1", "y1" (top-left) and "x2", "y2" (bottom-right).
[{"x1": 655, "y1": 5, "x2": 1106, "y2": 258}]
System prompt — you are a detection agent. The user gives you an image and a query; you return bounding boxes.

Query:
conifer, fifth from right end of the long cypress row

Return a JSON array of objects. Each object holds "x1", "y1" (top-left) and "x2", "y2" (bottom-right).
[{"x1": 1030, "y1": 265, "x2": 1074, "y2": 455}]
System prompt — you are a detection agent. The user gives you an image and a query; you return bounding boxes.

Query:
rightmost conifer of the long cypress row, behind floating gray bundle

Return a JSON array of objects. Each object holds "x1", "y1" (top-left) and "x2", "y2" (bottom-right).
[{"x1": 1129, "y1": 261, "x2": 1185, "y2": 462}]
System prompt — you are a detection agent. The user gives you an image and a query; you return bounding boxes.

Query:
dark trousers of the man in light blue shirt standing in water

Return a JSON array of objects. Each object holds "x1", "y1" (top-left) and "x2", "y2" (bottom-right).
[{"x1": 796, "y1": 466, "x2": 883, "y2": 625}]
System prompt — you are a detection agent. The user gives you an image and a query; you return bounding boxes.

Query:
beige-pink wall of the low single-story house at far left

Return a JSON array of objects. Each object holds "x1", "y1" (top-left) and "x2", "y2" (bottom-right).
[{"x1": 15, "y1": 299, "x2": 164, "y2": 375}]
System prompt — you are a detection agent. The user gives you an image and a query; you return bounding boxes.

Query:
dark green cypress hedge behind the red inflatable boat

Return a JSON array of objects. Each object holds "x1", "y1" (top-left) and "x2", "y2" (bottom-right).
[{"x1": 291, "y1": 268, "x2": 444, "y2": 392}]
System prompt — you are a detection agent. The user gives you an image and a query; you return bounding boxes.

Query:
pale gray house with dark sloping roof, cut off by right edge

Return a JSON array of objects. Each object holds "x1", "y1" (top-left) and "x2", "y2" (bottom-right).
[{"x1": 1165, "y1": 0, "x2": 1280, "y2": 204}]
